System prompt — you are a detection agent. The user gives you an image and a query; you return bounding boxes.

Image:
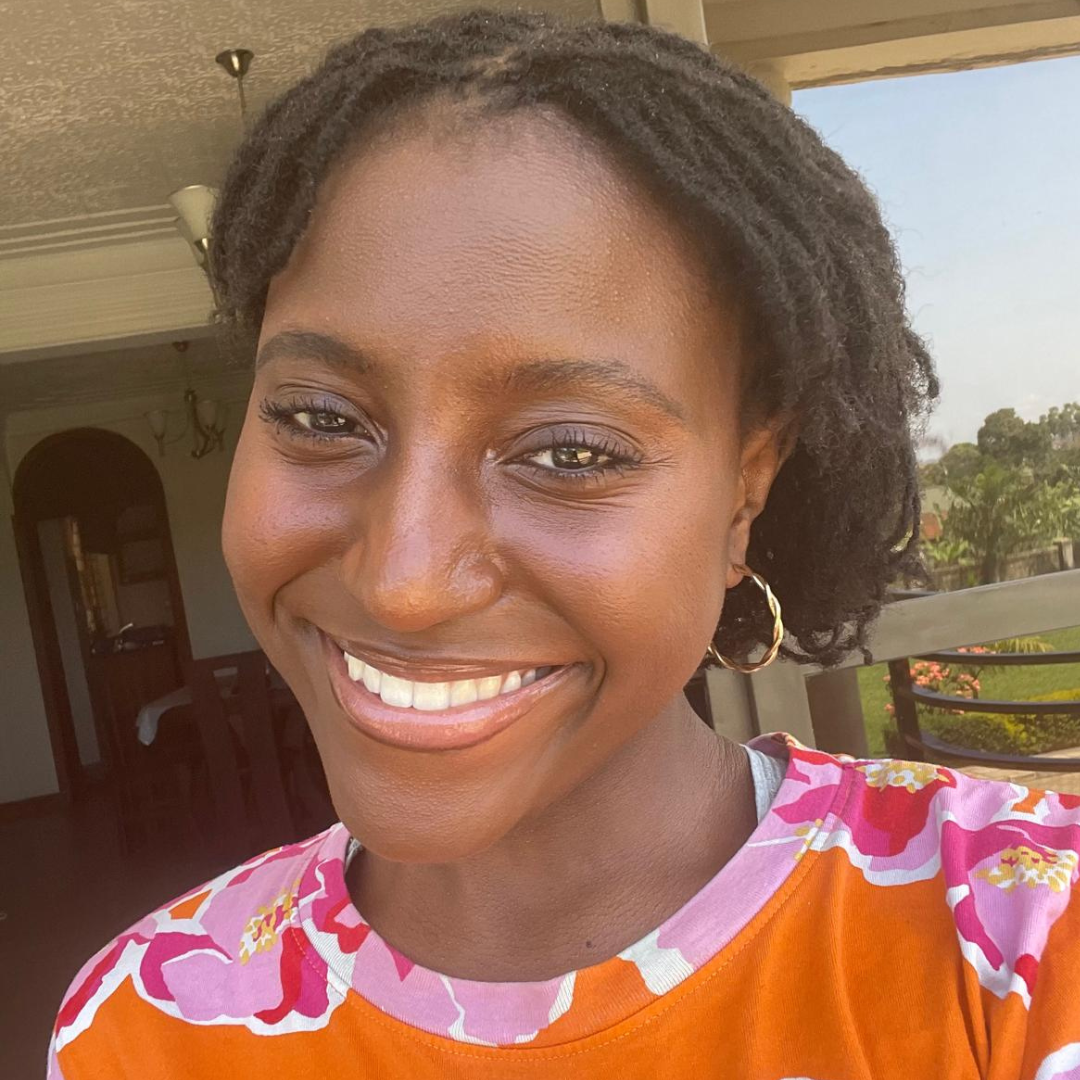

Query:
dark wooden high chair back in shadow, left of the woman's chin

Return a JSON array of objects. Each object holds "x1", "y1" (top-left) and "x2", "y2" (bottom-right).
[{"x1": 186, "y1": 650, "x2": 297, "y2": 854}]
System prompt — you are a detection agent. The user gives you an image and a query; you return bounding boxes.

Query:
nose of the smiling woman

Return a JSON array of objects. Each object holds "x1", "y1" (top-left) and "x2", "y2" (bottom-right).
[{"x1": 342, "y1": 453, "x2": 503, "y2": 633}]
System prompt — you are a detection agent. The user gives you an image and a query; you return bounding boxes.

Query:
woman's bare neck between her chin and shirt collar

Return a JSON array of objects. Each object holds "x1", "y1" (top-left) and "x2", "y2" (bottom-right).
[{"x1": 348, "y1": 696, "x2": 756, "y2": 982}]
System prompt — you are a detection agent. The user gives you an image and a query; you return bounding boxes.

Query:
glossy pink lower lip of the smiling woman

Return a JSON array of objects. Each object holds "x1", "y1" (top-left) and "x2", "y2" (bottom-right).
[{"x1": 323, "y1": 637, "x2": 578, "y2": 751}]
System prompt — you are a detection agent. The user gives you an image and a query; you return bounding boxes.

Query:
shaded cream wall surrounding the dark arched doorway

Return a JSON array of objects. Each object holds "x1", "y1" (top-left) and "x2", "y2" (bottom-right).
[{"x1": 0, "y1": 375, "x2": 255, "y2": 802}]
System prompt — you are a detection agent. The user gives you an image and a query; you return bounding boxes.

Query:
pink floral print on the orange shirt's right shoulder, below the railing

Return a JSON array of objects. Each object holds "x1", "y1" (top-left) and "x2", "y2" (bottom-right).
[{"x1": 788, "y1": 744, "x2": 1080, "y2": 1005}]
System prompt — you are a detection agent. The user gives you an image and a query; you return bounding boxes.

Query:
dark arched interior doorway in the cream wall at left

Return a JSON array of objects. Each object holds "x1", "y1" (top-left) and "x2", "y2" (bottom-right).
[{"x1": 13, "y1": 429, "x2": 191, "y2": 800}]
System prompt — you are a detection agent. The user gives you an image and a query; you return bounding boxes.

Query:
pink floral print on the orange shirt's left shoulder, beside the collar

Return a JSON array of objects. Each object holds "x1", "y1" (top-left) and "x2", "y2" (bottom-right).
[{"x1": 53, "y1": 825, "x2": 348, "y2": 1063}]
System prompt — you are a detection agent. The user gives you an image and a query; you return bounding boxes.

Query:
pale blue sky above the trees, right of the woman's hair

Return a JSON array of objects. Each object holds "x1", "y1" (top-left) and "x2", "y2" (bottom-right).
[{"x1": 794, "y1": 57, "x2": 1080, "y2": 451}]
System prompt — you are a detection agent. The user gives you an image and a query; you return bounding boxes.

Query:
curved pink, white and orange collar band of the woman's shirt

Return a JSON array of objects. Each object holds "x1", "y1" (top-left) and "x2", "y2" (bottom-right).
[{"x1": 300, "y1": 734, "x2": 847, "y2": 1047}]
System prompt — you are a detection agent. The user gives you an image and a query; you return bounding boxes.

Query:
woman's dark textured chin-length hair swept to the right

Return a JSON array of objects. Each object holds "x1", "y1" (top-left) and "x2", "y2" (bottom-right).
[{"x1": 211, "y1": 10, "x2": 937, "y2": 666}]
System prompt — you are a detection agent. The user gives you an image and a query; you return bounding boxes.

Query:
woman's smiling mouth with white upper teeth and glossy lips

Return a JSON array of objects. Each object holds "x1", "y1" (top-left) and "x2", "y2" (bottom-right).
[{"x1": 323, "y1": 634, "x2": 580, "y2": 751}]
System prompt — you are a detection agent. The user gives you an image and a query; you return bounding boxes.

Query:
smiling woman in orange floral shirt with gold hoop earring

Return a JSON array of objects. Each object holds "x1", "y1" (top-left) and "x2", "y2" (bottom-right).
[{"x1": 51, "y1": 12, "x2": 1080, "y2": 1080}]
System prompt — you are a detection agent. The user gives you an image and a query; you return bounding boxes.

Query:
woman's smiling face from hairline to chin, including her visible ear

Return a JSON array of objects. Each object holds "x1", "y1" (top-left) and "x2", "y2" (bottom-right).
[{"x1": 225, "y1": 113, "x2": 777, "y2": 862}]
